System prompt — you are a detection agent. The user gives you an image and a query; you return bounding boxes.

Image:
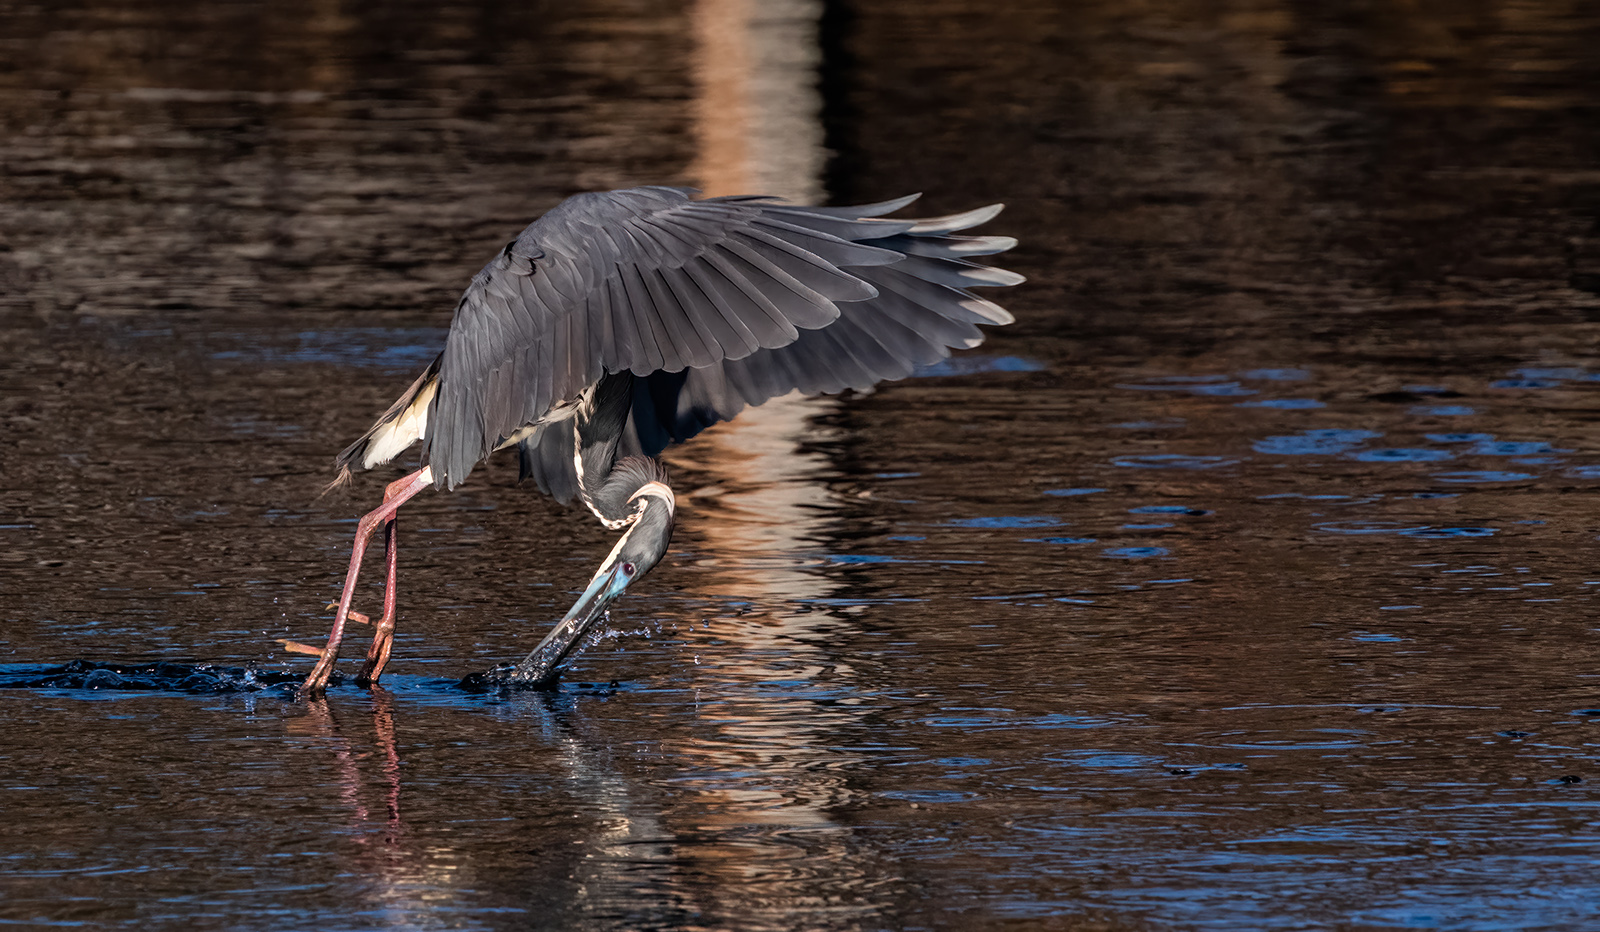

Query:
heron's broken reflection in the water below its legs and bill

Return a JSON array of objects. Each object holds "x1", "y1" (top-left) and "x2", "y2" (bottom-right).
[{"x1": 290, "y1": 698, "x2": 702, "y2": 929}]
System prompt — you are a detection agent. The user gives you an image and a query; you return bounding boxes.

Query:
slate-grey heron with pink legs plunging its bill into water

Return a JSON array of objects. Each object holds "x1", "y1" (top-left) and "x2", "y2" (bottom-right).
[{"x1": 293, "y1": 187, "x2": 1022, "y2": 697}]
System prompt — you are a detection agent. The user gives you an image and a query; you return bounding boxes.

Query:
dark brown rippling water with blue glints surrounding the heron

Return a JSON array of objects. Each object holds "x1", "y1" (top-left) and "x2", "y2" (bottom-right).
[{"x1": 0, "y1": 0, "x2": 1600, "y2": 930}]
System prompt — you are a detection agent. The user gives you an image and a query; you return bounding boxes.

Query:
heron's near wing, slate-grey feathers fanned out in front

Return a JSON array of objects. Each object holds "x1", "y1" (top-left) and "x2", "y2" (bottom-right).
[{"x1": 425, "y1": 187, "x2": 915, "y2": 487}]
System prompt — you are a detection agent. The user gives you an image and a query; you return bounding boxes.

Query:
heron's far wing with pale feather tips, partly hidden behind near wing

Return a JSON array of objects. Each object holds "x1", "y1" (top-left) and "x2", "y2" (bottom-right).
[{"x1": 522, "y1": 197, "x2": 1022, "y2": 501}]
